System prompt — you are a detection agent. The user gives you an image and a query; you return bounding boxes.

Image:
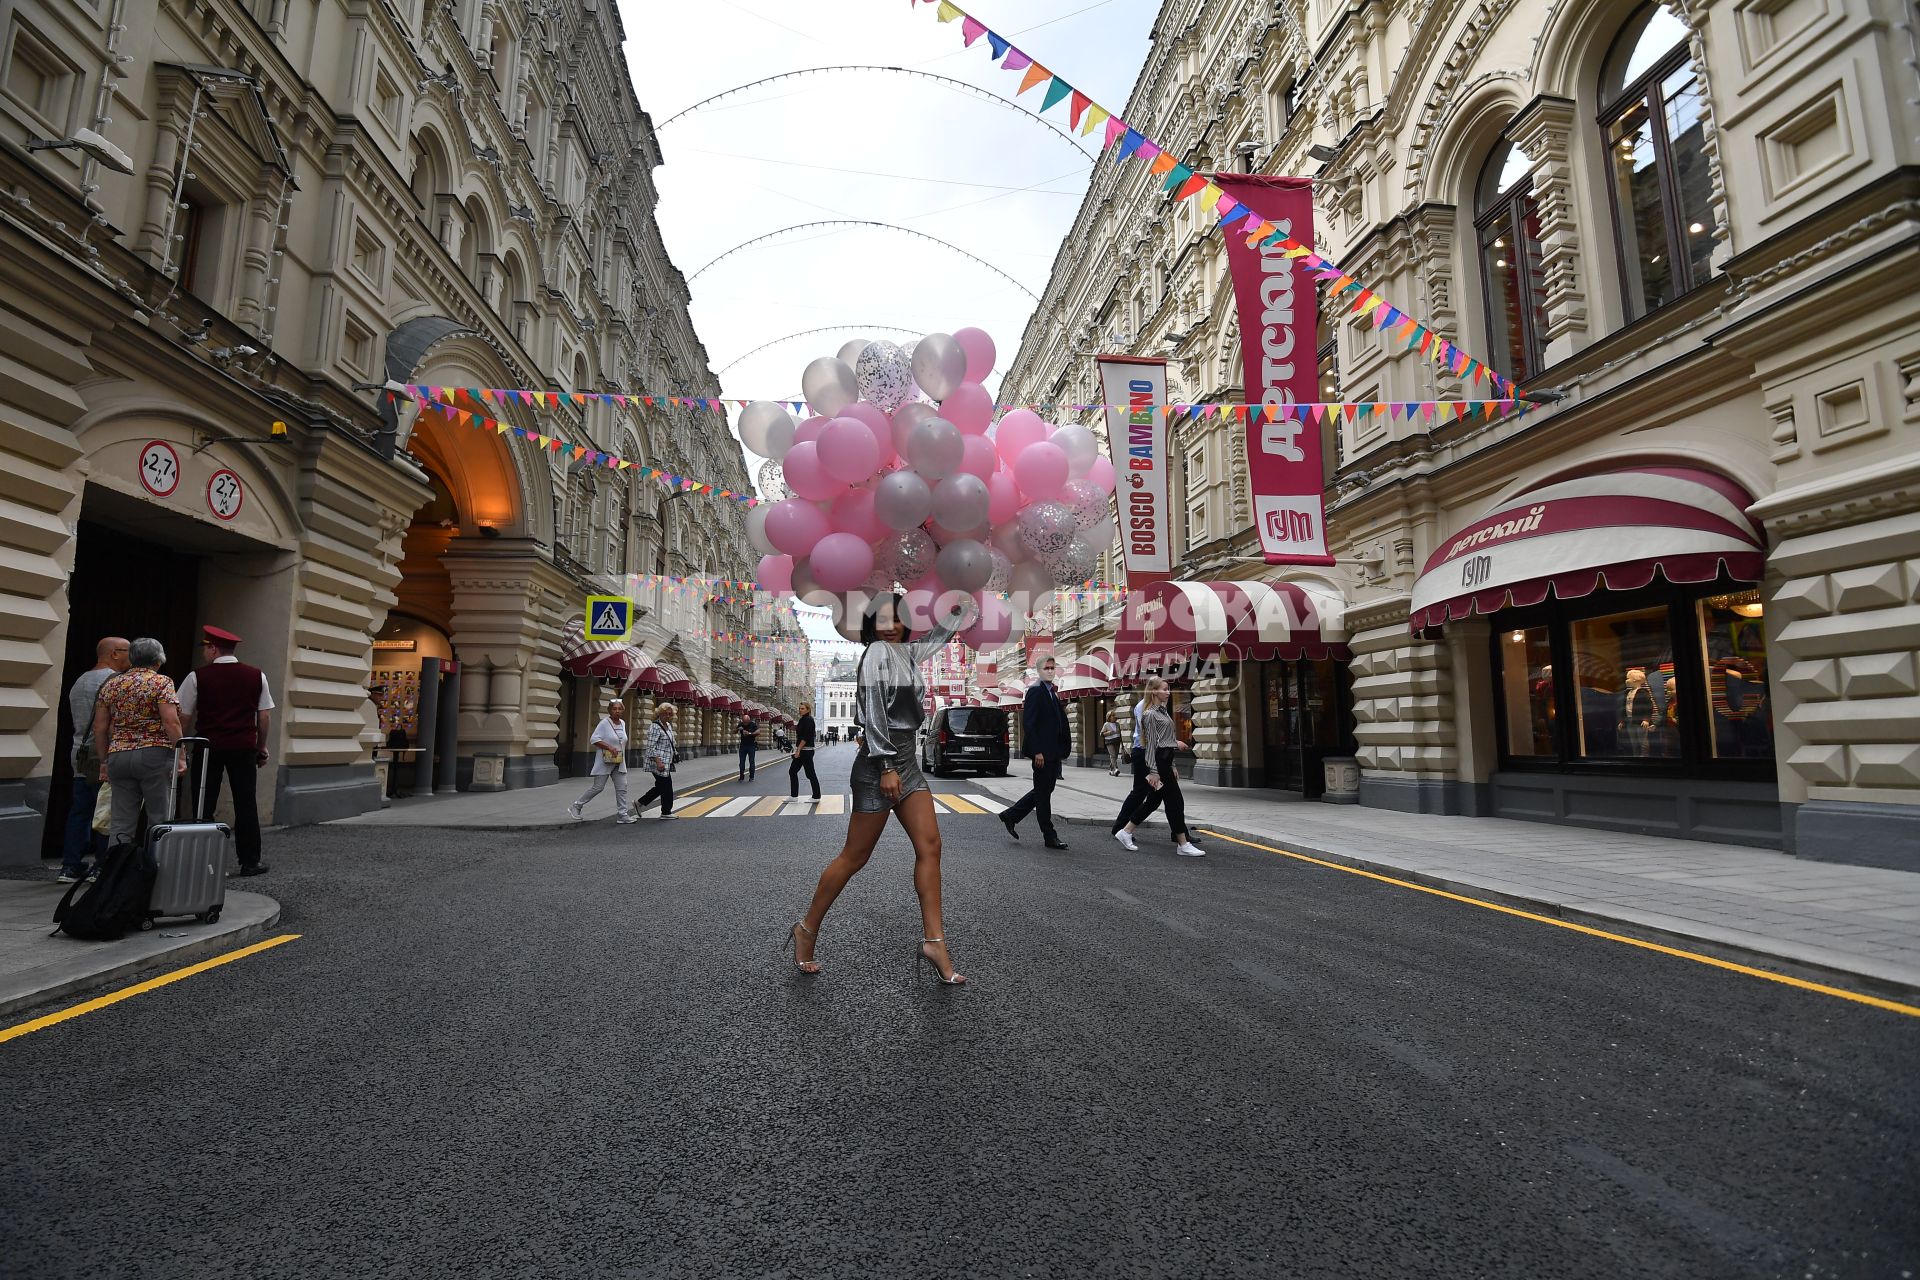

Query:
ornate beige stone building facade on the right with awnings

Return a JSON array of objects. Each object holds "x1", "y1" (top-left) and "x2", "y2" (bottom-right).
[{"x1": 1002, "y1": 0, "x2": 1920, "y2": 867}]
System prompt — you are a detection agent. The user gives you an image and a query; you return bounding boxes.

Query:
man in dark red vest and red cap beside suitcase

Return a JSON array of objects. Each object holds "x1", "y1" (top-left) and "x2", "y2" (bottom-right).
[{"x1": 179, "y1": 628, "x2": 273, "y2": 875}]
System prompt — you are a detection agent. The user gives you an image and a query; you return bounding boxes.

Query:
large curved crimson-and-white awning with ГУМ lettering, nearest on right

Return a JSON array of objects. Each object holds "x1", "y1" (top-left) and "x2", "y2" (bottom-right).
[{"x1": 1411, "y1": 464, "x2": 1766, "y2": 629}]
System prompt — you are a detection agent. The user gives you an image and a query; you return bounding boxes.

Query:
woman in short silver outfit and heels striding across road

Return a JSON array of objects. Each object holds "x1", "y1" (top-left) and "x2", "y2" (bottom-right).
[{"x1": 781, "y1": 595, "x2": 966, "y2": 986}]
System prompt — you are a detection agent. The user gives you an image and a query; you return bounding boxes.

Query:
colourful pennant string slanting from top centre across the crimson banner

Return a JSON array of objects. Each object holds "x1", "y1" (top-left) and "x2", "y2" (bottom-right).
[{"x1": 908, "y1": 0, "x2": 1515, "y2": 397}]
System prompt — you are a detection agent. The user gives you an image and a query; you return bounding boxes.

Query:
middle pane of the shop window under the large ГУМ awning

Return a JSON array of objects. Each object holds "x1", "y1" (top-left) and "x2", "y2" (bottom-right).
[{"x1": 1572, "y1": 608, "x2": 1680, "y2": 760}]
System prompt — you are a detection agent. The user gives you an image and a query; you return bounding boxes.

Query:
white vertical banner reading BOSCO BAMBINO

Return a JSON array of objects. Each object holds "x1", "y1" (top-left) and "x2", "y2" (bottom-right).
[{"x1": 1098, "y1": 355, "x2": 1173, "y2": 589}]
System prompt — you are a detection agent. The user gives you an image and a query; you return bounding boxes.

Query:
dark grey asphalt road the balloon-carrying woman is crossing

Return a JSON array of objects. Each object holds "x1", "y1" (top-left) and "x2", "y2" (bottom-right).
[{"x1": 0, "y1": 747, "x2": 1920, "y2": 1280}]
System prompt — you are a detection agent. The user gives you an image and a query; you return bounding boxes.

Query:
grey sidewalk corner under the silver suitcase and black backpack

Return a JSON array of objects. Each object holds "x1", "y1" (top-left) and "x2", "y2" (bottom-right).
[{"x1": 0, "y1": 882, "x2": 280, "y2": 1019}]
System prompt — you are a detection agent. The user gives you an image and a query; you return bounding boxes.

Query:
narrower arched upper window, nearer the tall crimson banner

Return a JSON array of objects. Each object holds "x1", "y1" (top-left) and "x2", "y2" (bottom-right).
[{"x1": 1473, "y1": 140, "x2": 1548, "y2": 382}]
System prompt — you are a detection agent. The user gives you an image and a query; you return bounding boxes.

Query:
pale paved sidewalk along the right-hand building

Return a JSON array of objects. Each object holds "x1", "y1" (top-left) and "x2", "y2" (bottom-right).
[{"x1": 970, "y1": 762, "x2": 1920, "y2": 992}]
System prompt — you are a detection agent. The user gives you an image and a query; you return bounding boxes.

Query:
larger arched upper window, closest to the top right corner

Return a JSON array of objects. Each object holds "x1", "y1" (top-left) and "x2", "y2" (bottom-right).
[{"x1": 1599, "y1": 4, "x2": 1722, "y2": 319}]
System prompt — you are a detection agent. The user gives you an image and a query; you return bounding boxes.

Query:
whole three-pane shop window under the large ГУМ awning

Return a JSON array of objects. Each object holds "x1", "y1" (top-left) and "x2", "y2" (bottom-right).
[{"x1": 1492, "y1": 581, "x2": 1774, "y2": 779}]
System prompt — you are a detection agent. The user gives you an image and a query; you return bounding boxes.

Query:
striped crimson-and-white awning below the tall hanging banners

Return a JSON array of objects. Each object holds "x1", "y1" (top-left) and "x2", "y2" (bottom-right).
[{"x1": 1112, "y1": 580, "x2": 1348, "y2": 667}]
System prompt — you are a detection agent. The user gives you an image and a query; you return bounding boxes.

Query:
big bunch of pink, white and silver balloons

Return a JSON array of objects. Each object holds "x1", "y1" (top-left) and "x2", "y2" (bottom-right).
[{"x1": 739, "y1": 328, "x2": 1114, "y2": 649}]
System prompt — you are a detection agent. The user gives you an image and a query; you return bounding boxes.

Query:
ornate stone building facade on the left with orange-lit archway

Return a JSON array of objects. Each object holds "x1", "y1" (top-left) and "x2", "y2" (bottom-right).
[{"x1": 0, "y1": 0, "x2": 783, "y2": 856}]
